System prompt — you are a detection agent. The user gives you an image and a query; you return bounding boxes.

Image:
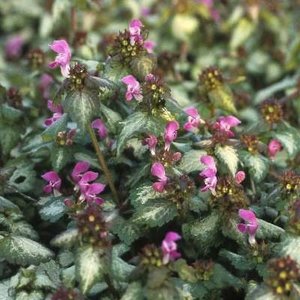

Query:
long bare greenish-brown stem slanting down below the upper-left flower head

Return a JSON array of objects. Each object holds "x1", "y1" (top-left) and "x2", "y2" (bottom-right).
[{"x1": 87, "y1": 125, "x2": 119, "y2": 203}]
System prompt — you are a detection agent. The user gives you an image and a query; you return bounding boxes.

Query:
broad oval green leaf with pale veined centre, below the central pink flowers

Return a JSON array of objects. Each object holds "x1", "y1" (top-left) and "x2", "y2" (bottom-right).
[{"x1": 132, "y1": 199, "x2": 177, "y2": 227}]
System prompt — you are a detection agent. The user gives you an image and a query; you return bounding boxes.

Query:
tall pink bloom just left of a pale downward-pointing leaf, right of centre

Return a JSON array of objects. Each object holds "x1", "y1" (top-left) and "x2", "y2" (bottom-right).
[{"x1": 200, "y1": 155, "x2": 218, "y2": 193}]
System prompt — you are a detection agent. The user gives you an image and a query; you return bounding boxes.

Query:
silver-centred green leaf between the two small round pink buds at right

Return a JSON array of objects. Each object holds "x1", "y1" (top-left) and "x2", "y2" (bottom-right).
[{"x1": 240, "y1": 151, "x2": 269, "y2": 182}]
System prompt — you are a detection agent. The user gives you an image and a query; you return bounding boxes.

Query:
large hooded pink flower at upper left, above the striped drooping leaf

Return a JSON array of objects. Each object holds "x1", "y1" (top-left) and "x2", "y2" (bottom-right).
[{"x1": 49, "y1": 40, "x2": 71, "y2": 77}]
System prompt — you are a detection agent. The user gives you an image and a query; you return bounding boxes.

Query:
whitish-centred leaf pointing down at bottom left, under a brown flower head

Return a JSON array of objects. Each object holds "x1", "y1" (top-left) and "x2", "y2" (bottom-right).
[{"x1": 76, "y1": 246, "x2": 107, "y2": 294}]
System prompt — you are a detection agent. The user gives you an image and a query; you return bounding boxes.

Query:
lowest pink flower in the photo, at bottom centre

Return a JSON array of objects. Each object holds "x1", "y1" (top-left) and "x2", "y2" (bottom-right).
[{"x1": 161, "y1": 231, "x2": 181, "y2": 265}]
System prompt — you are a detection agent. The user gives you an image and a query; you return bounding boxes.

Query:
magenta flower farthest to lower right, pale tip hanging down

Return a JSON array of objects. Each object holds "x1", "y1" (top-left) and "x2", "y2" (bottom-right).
[{"x1": 237, "y1": 209, "x2": 259, "y2": 245}]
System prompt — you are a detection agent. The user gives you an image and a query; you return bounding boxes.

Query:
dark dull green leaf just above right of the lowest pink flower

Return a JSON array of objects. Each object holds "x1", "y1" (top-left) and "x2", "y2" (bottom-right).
[{"x1": 182, "y1": 212, "x2": 220, "y2": 254}]
